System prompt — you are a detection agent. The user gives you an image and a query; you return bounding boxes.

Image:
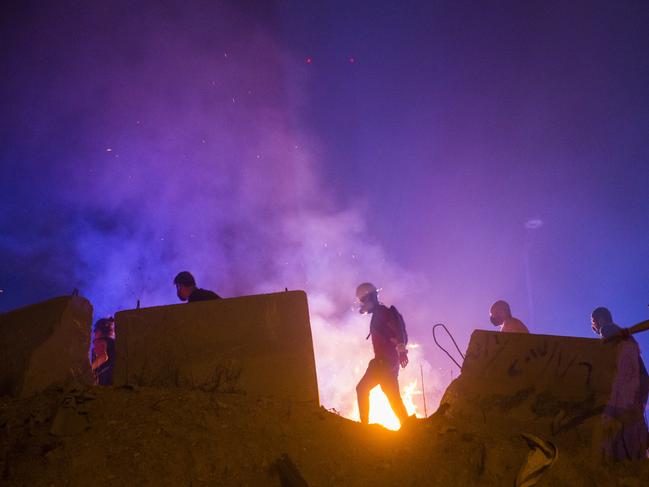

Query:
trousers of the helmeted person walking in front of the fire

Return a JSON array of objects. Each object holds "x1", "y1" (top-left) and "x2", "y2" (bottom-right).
[{"x1": 356, "y1": 358, "x2": 408, "y2": 425}]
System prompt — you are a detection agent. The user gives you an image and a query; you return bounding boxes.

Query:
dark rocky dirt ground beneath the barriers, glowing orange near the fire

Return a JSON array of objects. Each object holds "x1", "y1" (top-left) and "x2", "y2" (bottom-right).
[{"x1": 0, "y1": 387, "x2": 649, "y2": 487}]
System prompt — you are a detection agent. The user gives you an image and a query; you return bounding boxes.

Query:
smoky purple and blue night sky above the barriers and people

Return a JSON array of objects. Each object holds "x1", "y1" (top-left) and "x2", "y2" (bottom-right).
[{"x1": 0, "y1": 0, "x2": 649, "y2": 416}]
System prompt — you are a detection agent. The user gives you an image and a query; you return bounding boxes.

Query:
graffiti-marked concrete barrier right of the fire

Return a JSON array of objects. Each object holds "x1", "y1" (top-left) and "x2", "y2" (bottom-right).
[{"x1": 439, "y1": 330, "x2": 646, "y2": 458}]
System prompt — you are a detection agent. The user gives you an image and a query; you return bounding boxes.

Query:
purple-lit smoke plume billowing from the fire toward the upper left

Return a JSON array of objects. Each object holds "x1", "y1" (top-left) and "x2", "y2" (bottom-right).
[{"x1": 2, "y1": 2, "x2": 441, "y2": 416}]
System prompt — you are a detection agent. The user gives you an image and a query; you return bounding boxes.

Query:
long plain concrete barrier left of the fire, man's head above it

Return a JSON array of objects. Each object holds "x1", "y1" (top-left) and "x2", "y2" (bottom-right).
[{"x1": 114, "y1": 291, "x2": 319, "y2": 403}]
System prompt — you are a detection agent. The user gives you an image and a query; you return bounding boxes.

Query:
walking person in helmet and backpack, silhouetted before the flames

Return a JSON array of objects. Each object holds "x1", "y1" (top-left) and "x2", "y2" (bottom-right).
[{"x1": 356, "y1": 282, "x2": 408, "y2": 426}]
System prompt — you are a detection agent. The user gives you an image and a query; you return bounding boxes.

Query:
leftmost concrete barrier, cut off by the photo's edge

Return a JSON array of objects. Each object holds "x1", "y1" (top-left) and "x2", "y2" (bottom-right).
[{"x1": 0, "y1": 296, "x2": 92, "y2": 396}]
